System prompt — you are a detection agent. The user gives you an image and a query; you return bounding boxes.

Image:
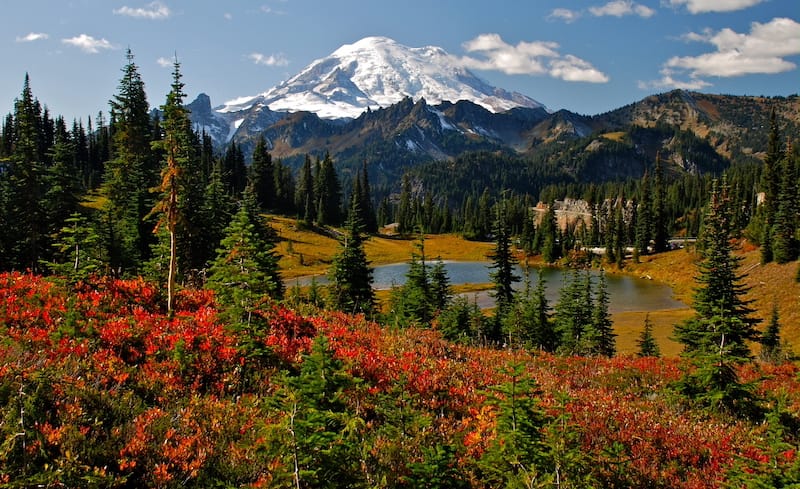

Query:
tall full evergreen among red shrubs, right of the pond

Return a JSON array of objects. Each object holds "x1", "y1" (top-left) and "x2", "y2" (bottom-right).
[{"x1": 675, "y1": 180, "x2": 758, "y2": 416}]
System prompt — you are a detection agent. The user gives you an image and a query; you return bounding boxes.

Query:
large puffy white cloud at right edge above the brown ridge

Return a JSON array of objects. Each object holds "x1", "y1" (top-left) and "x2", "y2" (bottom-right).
[{"x1": 650, "y1": 17, "x2": 800, "y2": 88}]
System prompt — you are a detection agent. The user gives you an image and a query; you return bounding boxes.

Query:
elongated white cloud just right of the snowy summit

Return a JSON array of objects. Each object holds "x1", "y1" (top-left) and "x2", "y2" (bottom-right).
[{"x1": 461, "y1": 34, "x2": 608, "y2": 83}]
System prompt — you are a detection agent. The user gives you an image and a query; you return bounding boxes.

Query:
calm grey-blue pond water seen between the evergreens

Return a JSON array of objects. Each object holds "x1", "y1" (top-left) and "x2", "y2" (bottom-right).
[{"x1": 287, "y1": 261, "x2": 686, "y2": 312}]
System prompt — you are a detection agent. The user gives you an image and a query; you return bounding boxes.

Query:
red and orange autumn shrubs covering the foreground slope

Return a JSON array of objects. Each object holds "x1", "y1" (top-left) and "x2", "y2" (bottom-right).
[{"x1": 0, "y1": 273, "x2": 800, "y2": 488}]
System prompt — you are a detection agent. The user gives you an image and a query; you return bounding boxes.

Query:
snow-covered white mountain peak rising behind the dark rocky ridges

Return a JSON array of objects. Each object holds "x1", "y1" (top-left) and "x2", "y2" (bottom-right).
[{"x1": 217, "y1": 37, "x2": 542, "y2": 119}]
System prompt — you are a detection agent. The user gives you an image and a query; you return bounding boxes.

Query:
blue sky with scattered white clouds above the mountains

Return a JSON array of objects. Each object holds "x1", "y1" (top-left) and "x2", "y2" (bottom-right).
[{"x1": 0, "y1": 0, "x2": 800, "y2": 120}]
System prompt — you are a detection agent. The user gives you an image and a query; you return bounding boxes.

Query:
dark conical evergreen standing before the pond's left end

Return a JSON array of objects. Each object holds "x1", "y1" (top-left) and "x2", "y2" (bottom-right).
[{"x1": 328, "y1": 198, "x2": 375, "y2": 317}]
